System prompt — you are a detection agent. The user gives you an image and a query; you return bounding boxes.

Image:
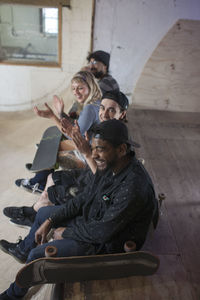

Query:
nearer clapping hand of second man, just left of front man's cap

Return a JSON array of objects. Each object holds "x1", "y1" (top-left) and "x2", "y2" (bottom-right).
[{"x1": 71, "y1": 121, "x2": 91, "y2": 156}]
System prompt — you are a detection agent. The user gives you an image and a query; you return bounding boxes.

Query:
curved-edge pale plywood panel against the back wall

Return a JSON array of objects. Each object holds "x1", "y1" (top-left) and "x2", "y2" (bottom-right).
[{"x1": 133, "y1": 20, "x2": 200, "y2": 112}]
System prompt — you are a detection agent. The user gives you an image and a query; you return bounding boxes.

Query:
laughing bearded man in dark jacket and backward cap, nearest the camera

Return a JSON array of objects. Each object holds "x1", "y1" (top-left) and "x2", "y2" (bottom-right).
[{"x1": 0, "y1": 119, "x2": 157, "y2": 300}]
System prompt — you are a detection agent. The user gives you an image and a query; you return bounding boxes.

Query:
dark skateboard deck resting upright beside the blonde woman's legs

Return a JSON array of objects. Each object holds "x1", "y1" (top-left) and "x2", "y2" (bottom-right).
[{"x1": 30, "y1": 126, "x2": 62, "y2": 172}]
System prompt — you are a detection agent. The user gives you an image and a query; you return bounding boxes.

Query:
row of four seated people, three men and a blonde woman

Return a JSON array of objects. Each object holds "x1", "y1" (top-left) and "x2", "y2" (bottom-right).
[{"x1": 0, "y1": 51, "x2": 157, "y2": 299}]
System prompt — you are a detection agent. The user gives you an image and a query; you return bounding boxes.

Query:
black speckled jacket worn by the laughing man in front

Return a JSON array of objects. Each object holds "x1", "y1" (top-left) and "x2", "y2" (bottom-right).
[{"x1": 51, "y1": 158, "x2": 157, "y2": 253}]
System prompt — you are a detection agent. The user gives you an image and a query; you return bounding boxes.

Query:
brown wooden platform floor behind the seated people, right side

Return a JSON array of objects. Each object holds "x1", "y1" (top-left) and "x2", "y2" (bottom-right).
[{"x1": 62, "y1": 109, "x2": 200, "y2": 300}]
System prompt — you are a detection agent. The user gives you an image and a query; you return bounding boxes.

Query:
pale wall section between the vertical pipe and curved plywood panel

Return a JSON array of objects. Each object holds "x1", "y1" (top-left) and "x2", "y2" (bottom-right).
[{"x1": 94, "y1": 0, "x2": 200, "y2": 110}]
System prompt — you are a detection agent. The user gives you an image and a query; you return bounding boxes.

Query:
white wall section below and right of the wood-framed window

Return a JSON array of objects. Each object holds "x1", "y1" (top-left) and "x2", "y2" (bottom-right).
[{"x1": 0, "y1": 0, "x2": 92, "y2": 111}]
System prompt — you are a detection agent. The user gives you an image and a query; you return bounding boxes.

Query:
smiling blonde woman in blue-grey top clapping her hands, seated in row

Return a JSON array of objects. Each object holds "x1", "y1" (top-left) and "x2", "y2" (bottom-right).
[{"x1": 15, "y1": 71, "x2": 102, "y2": 192}]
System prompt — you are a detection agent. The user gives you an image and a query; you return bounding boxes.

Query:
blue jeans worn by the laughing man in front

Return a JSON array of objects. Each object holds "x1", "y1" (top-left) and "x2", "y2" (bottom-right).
[{"x1": 6, "y1": 206, "x2": 95, "y2": 300}]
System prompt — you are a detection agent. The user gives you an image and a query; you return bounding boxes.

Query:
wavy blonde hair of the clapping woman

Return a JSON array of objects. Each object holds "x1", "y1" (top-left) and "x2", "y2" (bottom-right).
[{"x1": 71, "y1": 71, "x2": 102, "y2": 106}]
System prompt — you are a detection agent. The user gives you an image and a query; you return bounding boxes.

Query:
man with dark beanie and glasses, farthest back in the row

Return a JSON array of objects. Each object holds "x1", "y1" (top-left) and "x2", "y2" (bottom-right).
[{"x1": 86, "y1": 50, "x2": 119, "y2": 93}]
